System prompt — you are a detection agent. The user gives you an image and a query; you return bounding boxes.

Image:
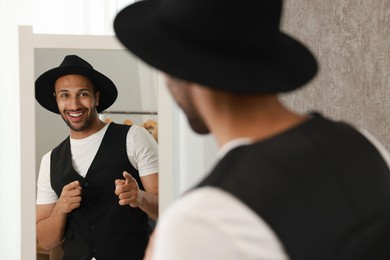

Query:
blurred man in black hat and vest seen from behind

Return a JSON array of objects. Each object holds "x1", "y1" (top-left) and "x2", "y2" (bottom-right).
[{"x1": 114, "y1": 0, "x2": 390, "y2": 260}]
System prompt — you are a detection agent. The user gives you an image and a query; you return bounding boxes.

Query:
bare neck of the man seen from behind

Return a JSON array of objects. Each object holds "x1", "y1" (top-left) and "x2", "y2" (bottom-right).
[{"x1": 204, "y1": 96, "x2": 308, "y2": 146}]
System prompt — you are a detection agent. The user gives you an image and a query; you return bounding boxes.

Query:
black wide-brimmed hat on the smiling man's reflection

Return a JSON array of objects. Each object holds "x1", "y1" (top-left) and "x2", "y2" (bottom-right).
[{"x1": 35, "y1": 55, "x2": 118, "y2": 114}]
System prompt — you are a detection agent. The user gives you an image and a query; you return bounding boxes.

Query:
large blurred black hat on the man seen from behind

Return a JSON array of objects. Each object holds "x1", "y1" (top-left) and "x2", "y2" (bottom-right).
[{"x1": 114, "y1": 0, "x2": 317, "y2": 93}]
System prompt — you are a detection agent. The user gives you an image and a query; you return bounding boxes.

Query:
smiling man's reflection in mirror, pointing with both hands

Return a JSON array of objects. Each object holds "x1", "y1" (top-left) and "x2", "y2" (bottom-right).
[{"x1": 35, "y1": 55, "x2": 158, "y2": 260}]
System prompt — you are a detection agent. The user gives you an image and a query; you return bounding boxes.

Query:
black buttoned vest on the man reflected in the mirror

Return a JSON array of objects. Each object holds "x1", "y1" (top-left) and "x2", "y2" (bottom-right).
[{"x1": 50, "y1": 123, "x2": 149, "y2": 260}]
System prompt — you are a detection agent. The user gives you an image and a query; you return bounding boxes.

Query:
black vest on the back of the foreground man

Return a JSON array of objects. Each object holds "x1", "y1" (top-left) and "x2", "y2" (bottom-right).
[{"x1": 199, "y1": 115, "x2": 390, "y2": 260}]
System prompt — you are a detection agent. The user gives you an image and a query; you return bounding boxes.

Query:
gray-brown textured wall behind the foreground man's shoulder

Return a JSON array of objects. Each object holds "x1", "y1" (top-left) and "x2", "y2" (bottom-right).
[{"x1": 282, "y1": 0, "x2": 390, "y2": 149}]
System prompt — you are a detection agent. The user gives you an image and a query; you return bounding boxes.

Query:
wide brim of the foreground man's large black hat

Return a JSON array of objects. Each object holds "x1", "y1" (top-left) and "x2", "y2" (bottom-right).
[{"x1": 114, "y1": 1, "x2": 318, "y2": 93}]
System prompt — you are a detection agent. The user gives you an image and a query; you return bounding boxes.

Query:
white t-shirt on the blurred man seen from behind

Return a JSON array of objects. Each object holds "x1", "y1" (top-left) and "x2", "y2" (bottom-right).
[{"x1": 152, "y1": 131, "x2": 390, "y2": 260}]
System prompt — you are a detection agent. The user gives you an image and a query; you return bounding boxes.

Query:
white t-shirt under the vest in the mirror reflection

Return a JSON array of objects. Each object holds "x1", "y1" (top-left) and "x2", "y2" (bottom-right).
[{"x1": 36, "y1": 124, "x2": 158, "y2": 204}]
